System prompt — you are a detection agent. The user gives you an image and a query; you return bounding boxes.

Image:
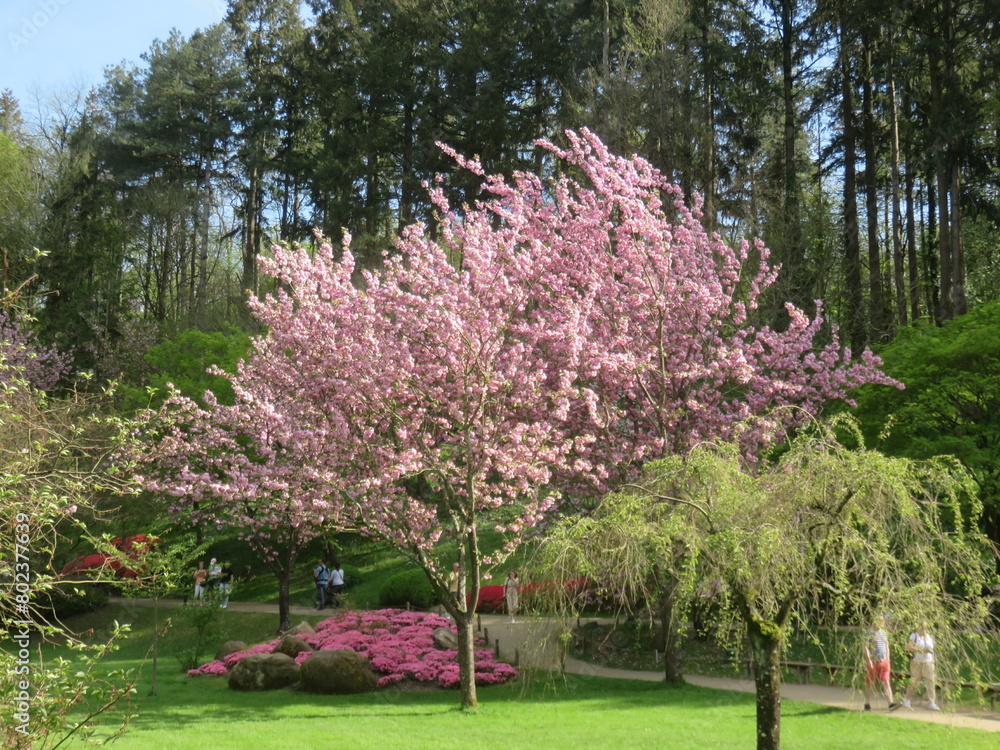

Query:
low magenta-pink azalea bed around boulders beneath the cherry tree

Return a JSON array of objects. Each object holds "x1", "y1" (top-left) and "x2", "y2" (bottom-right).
[{"x1": 188, "y1": 609, "x2": 517, "y2": 688}]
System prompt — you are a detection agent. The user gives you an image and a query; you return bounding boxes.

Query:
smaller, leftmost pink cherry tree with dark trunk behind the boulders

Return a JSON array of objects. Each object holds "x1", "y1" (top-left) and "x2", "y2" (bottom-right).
[{"x1": 133, "y1": 376, "x2": 350, "y2": 631}]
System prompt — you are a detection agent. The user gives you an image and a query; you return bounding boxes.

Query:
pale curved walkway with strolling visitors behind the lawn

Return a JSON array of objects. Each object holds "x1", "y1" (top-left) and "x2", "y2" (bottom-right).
[{"x1": 109, "y1": 597, "x2": 1000, "y2": 732}]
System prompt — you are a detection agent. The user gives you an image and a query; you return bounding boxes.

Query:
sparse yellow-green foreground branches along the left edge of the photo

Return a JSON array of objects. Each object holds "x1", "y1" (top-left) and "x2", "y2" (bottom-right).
[{"x1": 0, "y1": 363, "x2": 143, "y2": 750}]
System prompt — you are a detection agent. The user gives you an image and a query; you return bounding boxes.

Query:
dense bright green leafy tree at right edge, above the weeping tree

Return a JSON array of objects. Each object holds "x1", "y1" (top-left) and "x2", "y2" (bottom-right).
[{"x1": 857, "y1": 301, "x2": 1000, "y2": 542}]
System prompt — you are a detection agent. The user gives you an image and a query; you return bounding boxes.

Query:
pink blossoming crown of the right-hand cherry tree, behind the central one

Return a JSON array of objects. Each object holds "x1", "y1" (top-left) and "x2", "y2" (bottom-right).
[{"x1": 456, "y1": 130, "x2": 899, "y2": 484}]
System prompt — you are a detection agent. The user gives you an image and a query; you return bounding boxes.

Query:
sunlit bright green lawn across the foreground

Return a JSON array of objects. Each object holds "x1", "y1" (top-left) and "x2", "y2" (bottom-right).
[{"x1": 45, "y1": 605, "x2": 997, "y2": 750}]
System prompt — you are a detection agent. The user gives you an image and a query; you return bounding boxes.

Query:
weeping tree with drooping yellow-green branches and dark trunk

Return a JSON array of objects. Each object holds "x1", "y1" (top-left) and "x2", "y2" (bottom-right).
[{"x1": 542, "y1": 417, "x2": 996, "y2": 748}]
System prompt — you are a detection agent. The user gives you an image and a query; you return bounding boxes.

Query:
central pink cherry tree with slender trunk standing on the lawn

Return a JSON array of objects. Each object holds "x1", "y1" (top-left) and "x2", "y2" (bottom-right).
[{"x1": 237, "y1": 223, "x2": 589, "y2": 707}]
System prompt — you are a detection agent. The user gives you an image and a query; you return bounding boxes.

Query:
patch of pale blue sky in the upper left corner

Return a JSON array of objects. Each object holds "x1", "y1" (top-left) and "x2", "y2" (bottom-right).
[{"x1": 0, "y1": 0, "x2": 226, "y2": 111}]
